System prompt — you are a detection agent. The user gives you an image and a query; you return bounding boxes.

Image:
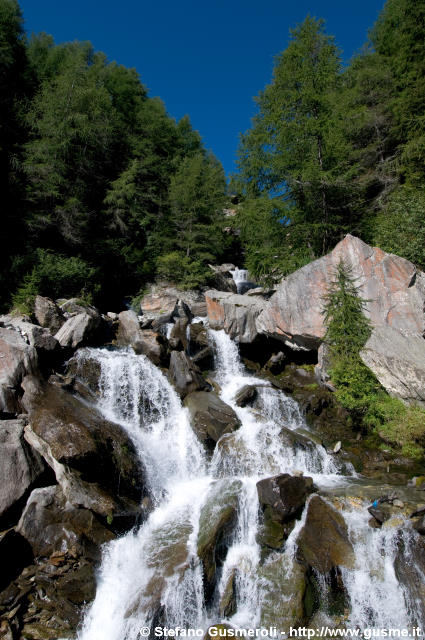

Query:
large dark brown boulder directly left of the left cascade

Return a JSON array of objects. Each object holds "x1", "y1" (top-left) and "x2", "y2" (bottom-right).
[{"x1": 25, "y1": 384, "x2": 144, "y2": 521}]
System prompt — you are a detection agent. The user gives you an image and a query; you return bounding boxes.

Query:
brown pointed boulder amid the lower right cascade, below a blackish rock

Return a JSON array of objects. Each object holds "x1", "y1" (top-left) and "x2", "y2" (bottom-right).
[{"x1": 297, "y1": 496, "x2": 355, "y2": 574}]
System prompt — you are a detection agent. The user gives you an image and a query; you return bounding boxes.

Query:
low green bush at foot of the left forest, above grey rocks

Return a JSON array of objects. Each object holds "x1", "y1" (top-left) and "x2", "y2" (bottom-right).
[{"x1": 12, "y1": 249, "x2": 97, "y2": 313}]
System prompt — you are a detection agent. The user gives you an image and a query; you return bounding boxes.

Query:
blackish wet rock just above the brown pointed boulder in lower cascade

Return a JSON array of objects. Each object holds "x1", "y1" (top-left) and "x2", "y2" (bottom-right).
[{"x1": 253, "y1": 473, "x2": 313, "y2": 523}]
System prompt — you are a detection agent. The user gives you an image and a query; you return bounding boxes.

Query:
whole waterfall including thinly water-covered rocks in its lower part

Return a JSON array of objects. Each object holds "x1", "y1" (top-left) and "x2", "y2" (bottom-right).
[{"x1": 78, "y1": 331, "x2": 425, "y2": 640}]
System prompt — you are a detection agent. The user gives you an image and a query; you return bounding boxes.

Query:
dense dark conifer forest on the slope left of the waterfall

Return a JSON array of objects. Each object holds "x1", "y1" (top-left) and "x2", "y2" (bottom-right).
[{"x1": 0, "y1": 0, "x2": 232, "y2": 307}]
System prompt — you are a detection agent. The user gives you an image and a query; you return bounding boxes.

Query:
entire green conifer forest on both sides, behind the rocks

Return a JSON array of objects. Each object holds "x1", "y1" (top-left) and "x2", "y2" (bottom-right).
[{"x1": 0, "y1": 0, "x2": 425, "y2": 310}]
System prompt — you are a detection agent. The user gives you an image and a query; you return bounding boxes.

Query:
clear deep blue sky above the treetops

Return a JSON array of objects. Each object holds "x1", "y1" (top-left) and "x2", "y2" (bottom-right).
[{"x1": 20, "y1": 0, "x2": 384, "y2": 173}]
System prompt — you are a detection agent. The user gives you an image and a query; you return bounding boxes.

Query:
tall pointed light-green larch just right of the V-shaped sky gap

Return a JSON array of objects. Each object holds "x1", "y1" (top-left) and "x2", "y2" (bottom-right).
[{"x1": 239, "y1": 16, "x2": 352, "y2": 268}]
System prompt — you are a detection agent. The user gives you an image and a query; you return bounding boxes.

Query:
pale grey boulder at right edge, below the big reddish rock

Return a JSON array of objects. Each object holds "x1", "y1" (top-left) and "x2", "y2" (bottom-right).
[{"x1": 360, "y1": 326, "x2": 425, "y2": 406}]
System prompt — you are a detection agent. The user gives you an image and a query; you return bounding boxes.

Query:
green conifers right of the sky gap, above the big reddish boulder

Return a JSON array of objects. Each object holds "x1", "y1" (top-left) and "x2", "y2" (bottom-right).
[{"x1": 233, "y1": 0, "x2": 425, "y2": 279}]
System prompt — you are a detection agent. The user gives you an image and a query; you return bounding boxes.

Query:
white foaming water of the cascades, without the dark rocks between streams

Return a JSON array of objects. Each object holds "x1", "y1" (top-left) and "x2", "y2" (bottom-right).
[{"x1": 78, "y1": 331, "x2": 422, "y2": 640}]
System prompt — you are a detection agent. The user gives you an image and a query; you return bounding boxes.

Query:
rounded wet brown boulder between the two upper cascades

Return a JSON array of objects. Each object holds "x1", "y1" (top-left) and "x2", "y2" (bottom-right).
[{"x1": 183, "y1": 391, "x2": 240, "y2": 448}]
